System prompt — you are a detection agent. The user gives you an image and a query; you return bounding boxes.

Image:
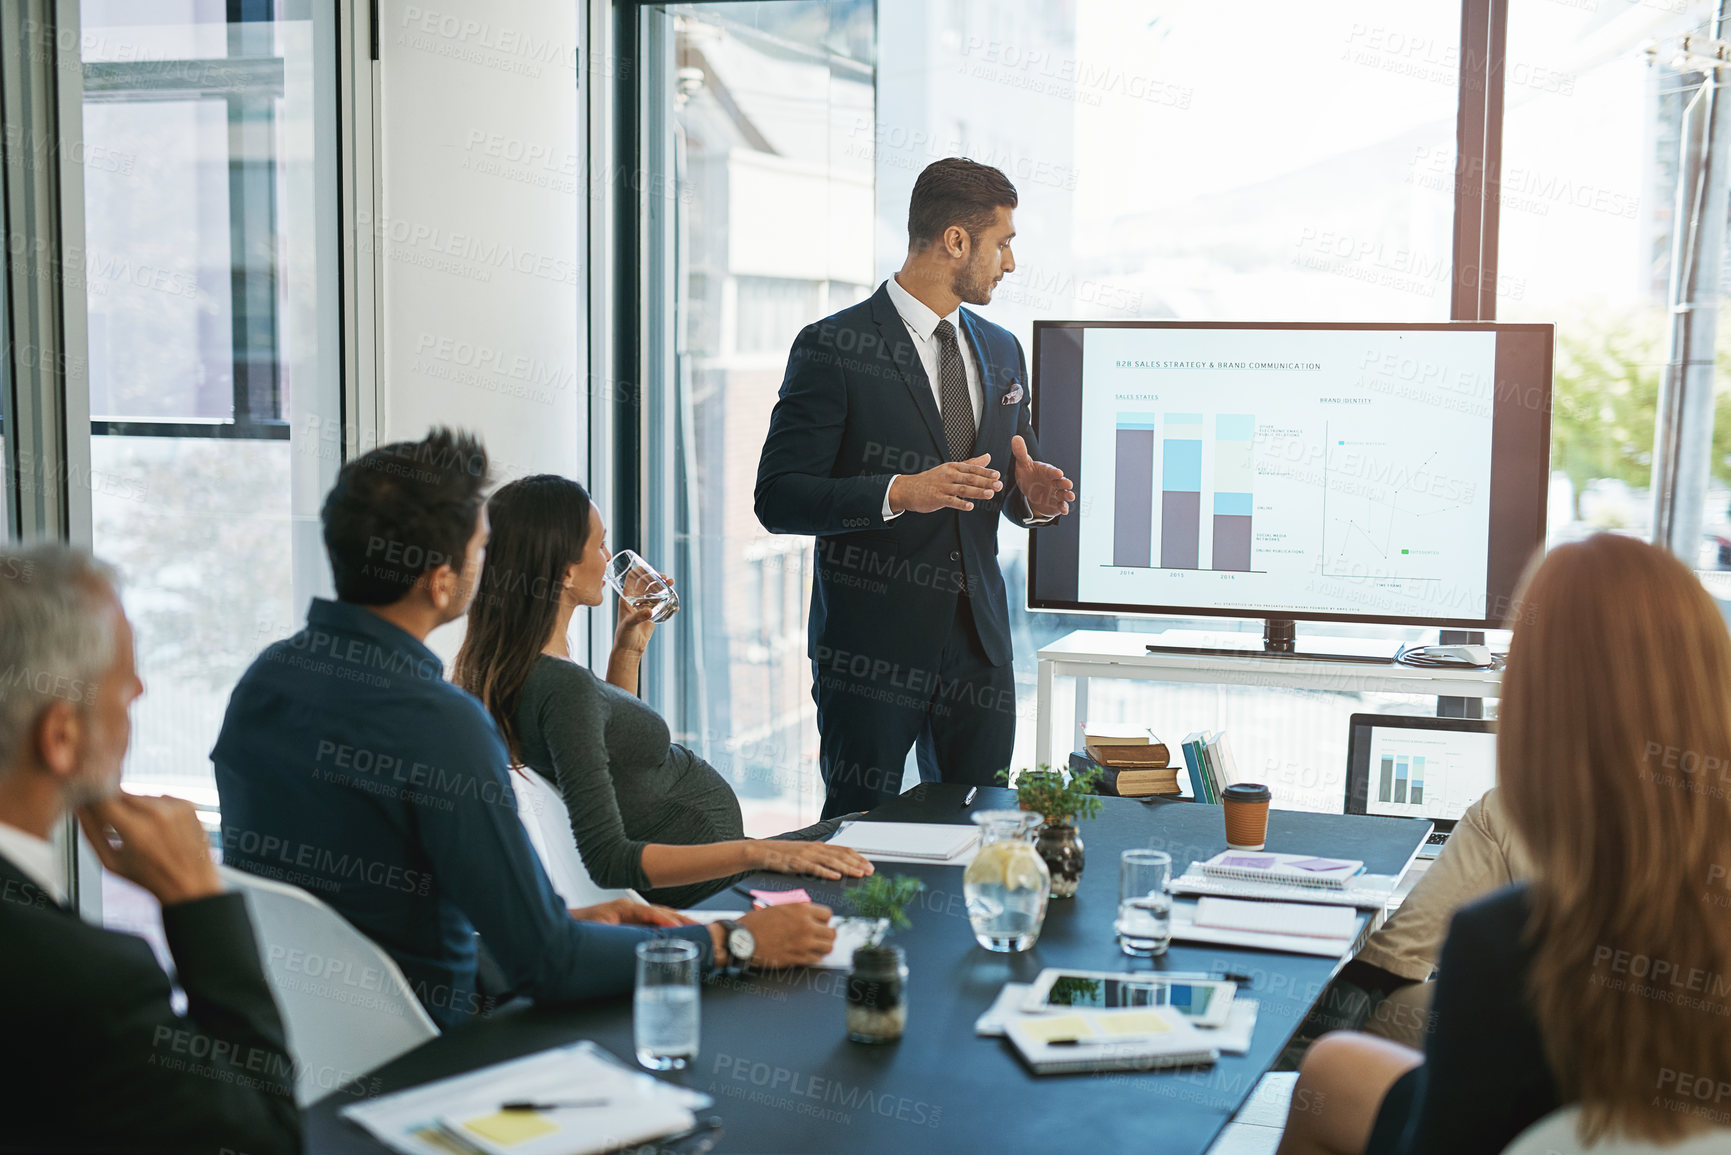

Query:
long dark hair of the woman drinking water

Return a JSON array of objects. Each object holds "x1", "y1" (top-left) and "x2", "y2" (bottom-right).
[{"x1": 452, "y1": 473, "x2": 589, "y2": 758}]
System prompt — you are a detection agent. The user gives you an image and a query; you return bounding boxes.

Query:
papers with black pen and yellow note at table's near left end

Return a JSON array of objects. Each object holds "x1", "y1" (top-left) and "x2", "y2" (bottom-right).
[{"x1": 339, "y1": 1039, "x2": 713, "y2": 1155}]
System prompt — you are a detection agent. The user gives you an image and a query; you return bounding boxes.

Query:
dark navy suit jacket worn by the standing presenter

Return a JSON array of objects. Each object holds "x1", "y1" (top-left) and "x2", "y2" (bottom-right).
[{"x1": 756, "y1": 286, "x2": 1039, "y2": 671}]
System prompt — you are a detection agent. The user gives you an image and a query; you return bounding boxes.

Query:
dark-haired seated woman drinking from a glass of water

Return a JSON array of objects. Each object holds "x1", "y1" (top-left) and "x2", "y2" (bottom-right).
[{"x1": 454, "y1": 474, "x2": 872, "y2": 906}]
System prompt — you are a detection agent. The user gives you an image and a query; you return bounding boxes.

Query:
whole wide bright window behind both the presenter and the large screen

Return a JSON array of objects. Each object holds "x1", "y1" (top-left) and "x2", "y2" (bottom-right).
[{"x1": 646, "y1": 0, "x2": 1459, "y2": 833}]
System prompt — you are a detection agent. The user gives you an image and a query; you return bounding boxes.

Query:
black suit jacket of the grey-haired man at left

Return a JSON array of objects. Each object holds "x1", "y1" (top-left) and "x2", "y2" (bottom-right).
[{"x1": 0, "y1": 857, "x2": 301, "y2": 1155}]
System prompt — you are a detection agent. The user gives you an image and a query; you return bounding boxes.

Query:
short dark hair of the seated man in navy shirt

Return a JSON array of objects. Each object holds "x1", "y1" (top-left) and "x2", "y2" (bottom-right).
[{"x1": 319, "y1": 426, "x2": 486, "y2": 606}]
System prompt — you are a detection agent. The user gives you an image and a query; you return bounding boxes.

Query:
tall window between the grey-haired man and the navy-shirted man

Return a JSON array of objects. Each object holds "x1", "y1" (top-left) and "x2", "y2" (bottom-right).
[{"x1": 80, "y1": 0, "x2": 339, "y2": 820}]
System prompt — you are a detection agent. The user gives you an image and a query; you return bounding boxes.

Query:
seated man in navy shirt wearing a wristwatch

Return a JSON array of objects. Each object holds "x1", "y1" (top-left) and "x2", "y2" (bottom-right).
[{"x1": 211, "y1": 429, "x2": 834, "y2": 1027}]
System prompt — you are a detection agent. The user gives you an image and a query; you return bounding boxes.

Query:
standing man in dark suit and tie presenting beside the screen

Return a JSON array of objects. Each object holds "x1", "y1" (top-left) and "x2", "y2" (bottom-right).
[{"x1": 756, "y1": 158, "x2": 1075, "y2": 817}]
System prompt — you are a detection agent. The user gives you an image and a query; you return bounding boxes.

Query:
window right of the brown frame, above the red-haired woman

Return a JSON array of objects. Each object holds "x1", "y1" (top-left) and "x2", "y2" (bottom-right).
[{"x1": 1497, "y1": 0, "x2": 1731, "y2": 578}]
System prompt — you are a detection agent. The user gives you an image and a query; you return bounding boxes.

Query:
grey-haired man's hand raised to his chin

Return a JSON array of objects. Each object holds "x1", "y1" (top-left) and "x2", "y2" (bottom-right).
[{"x1": 78, "y1": 793, "x2": 222, "y2": 906}]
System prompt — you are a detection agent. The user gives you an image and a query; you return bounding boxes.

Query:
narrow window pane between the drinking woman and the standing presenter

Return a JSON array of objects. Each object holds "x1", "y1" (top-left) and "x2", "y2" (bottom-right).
[{"x1": 646, "y1": 0, "x2": 878, "y2": 833}]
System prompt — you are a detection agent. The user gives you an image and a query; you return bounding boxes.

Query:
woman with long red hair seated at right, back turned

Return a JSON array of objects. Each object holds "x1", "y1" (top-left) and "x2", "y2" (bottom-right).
[{"x1": 1281, "y1": 533, "x2": 1731, "y2": 1155}]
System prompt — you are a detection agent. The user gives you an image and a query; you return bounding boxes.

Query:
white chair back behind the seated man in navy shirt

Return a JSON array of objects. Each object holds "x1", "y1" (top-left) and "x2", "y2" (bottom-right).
[{"x1": 222, "y1": 866, "x2": 438, "y2": 1107}]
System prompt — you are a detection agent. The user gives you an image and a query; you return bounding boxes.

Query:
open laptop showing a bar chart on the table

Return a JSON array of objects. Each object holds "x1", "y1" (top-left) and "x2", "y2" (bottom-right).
[{"x1": 1347, "y1": 713, "x2": 1497, "y2": 857}]
